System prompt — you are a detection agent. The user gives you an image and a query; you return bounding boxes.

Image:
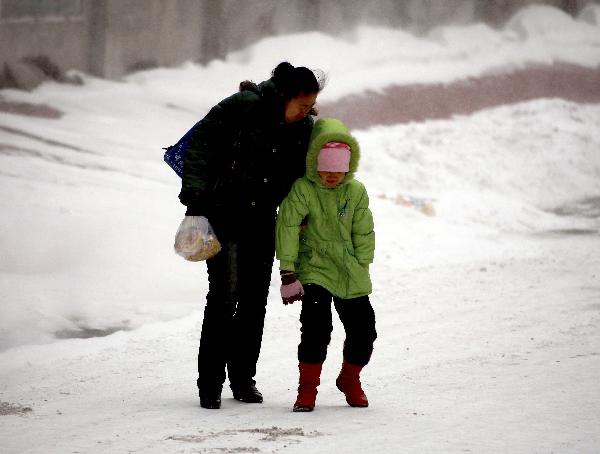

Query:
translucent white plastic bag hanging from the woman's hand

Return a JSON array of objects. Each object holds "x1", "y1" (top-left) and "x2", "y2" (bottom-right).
[{"x1": 175, "y1": 216, "x2": 221, "y2": 262}]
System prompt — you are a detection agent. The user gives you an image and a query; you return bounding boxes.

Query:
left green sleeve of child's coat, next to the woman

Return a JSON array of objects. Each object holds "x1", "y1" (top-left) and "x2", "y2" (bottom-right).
[{"x1": 275, "y1": 179, "x2": 309, "y2": 271}]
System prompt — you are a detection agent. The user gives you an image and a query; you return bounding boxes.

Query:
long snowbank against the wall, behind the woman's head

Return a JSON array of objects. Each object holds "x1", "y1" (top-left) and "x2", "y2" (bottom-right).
[{"x1": 128, "y1": 5, "x2": 600, "y2": 104}]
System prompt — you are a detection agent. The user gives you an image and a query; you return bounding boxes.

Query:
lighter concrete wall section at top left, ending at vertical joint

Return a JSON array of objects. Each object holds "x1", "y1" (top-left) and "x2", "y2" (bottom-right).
[{"x1": 0, "y1": 0, "x2": 208, "y2": 88}]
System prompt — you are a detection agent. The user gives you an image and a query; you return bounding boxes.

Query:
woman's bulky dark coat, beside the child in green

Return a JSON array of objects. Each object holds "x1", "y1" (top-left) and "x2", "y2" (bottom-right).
[{"x1": 179, "y1": 79, "x2": 313, "y2": 236}]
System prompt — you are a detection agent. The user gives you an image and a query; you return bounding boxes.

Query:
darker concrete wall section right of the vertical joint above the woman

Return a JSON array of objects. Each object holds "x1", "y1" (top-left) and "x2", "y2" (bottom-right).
[{"x1": 196, "y1": 0, "x2": 598, "y2": 60}]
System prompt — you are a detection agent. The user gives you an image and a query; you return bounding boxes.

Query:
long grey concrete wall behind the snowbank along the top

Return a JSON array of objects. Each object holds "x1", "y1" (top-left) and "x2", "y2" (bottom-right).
[{"x1": 0, "y1": 0, "x2": 600, "y2": 88}]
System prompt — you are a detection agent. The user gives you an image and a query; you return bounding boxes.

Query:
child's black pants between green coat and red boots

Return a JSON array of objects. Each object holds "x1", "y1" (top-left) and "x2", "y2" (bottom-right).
[{"x1": 298, "y1": 284, "x2": 377, "y2": 366}]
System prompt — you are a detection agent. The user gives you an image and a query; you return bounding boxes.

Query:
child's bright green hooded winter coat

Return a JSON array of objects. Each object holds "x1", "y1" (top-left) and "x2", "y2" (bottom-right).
[{"x1": 276, "y1": 118, "x2": 375, "y2": 299}]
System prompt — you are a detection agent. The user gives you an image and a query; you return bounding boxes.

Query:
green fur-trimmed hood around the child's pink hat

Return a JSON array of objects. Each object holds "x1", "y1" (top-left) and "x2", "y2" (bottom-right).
[{"x1": 306, "y1": 118, "x2": 360, "y2": 185}]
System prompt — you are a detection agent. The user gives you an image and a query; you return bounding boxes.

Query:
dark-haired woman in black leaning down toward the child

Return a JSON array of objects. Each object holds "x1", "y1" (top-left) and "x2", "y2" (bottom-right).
[{"x1": 179, "y1": 62, "x2": 322, "y2": 409}]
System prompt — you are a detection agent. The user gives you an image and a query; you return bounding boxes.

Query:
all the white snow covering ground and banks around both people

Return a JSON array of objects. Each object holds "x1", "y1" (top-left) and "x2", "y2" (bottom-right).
[{"x1": 0, "y1": 6, "x2": 600, "y2": 453}]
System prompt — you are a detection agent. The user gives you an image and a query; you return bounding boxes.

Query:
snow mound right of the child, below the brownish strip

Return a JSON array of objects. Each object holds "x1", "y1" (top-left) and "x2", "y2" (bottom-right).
[{"x1": 357, "y1": 100, "x2": 600, "y2": 232}]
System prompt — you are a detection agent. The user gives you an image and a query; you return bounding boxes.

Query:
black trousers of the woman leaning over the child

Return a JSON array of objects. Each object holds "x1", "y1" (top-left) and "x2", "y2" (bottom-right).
[{"x1": 198, "y1": 218, "x2": 275, "y2": 393}]
